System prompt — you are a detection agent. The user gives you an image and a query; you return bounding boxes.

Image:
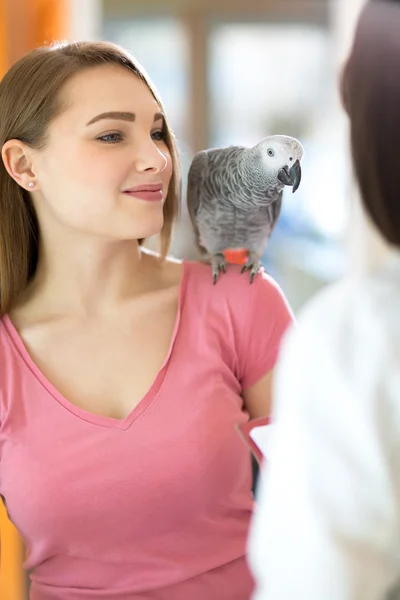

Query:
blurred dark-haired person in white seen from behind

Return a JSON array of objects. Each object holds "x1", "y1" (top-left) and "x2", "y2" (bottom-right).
[{"x1": 249, "y1": 0, "x2": 400, "y2": 600}]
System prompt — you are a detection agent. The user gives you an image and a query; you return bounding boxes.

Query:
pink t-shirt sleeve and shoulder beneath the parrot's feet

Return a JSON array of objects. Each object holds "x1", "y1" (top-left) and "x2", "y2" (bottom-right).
[{"x1": 181, "y1": 262, "x2": 293, "y2": 389}]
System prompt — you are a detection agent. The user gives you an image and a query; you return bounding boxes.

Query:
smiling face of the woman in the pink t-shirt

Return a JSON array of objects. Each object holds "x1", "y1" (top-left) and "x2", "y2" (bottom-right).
[{"x1": 32, "y1": 65, "x2": 172, "y2": 240}]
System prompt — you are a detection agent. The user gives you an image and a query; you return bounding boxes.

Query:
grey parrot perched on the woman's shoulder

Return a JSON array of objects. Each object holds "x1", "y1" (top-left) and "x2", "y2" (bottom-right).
[{"x1": 187, "y1": 135, "x2": 304, "y2": 283}]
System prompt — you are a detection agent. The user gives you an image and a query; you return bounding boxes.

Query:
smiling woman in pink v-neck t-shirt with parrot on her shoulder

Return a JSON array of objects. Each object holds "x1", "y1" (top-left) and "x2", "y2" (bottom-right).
[{"x1": 0, "y1": 42, "x2": 292, "y2": 600}]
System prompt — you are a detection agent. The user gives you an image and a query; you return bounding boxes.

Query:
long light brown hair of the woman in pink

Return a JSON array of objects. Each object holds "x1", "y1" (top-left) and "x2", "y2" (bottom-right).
[{"x1": 0, "y1": 42, "x2": 180, "y2": 314}]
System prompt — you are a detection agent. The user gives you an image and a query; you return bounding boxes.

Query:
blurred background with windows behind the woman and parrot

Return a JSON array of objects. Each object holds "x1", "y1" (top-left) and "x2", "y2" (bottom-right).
[{"x1": 0, "y1": 0, "x2": 387, "y2": 600}]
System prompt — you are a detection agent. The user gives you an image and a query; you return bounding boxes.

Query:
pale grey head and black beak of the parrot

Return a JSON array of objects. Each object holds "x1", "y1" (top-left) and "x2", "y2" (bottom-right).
[{"x1": 256, "y1": 135, "x2": 304, "y2": 193}]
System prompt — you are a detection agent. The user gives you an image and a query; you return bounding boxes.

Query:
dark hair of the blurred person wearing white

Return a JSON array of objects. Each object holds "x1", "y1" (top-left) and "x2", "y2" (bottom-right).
[{"x1": 341, "y1": 0, "x2": 400, "y2": 246}]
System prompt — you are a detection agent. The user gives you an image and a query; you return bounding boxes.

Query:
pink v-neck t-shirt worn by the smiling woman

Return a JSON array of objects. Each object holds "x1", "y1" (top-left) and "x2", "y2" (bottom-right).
[{"x1": 0, "y1": 262, "x2": 292, "y2": 600}]
